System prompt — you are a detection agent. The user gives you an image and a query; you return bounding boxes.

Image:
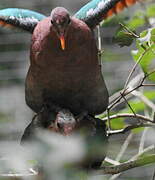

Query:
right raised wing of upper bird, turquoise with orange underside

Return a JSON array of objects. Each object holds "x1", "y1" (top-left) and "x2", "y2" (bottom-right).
[{"x1": 74, "y1": 0, "x2": 138, "y2": 28}]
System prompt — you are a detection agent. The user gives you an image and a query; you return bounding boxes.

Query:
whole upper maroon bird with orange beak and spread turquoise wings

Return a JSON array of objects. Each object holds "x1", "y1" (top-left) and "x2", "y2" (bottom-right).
[{"x1": 0, "y1": 0, "x2": 136, "y2": 118}]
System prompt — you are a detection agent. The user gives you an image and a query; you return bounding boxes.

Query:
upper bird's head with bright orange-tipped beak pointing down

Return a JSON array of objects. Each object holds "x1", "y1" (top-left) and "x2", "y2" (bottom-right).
[{"x1": 51, "y1": 7, "x2": 71, "y2": 50}]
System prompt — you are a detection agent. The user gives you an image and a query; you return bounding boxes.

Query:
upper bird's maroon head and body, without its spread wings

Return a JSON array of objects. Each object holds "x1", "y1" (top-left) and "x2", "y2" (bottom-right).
[{"x1": 25, "y1": 7, "x2": 108, "y2": 115}]
